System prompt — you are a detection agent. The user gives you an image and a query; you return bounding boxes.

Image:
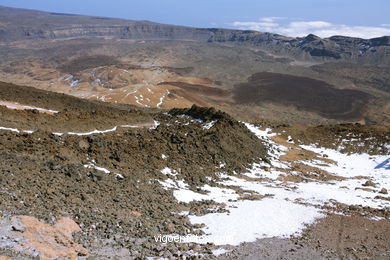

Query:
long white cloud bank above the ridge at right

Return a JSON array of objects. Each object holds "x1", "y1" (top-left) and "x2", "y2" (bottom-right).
[{"x1": 231, "y1": 17, "x2": 390, "y2": 39}]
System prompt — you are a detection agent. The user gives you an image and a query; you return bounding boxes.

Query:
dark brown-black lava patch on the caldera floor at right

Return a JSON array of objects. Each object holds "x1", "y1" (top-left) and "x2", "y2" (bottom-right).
[{"x1": 234, "y1": 72, "x2": 370, "y2": 119}]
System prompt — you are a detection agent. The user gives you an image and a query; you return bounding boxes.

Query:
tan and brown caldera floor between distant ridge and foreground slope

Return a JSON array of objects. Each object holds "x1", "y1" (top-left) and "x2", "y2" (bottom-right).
[{"x1": 0, "y1": 38, "x2": 390, "y2": 125}]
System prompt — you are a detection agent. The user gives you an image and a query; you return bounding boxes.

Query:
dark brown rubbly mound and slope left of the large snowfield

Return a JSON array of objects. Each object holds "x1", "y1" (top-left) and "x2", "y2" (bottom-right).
[{"x1": 0, "y1": 84, "x2": 267, "y2": 258}]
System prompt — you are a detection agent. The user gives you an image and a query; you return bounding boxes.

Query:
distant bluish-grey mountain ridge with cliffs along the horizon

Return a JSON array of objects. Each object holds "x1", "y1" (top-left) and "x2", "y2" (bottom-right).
[{"x1": 0, "y1": 7, "x2": 390, "y2": 65}]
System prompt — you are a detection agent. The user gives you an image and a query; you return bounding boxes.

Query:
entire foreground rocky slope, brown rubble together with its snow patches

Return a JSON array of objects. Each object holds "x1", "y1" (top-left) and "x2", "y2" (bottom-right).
[{"x1": 0, "y1": 83, "x2": 390, "y2": 259}]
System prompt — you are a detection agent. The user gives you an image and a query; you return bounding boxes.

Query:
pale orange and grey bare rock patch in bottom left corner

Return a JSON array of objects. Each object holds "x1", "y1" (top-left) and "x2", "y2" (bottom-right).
[{"x1": 0, "y1": 216, "x2": 88, "y2": 260}]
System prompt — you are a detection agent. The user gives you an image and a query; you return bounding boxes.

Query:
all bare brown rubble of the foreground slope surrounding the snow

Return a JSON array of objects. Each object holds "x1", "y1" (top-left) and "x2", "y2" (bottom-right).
[{"x1": 0, "y1": 84, "x2": 390, "y2": 259}]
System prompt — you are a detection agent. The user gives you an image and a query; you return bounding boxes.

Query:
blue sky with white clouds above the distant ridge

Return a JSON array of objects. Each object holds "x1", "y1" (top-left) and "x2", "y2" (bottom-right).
[{"x1": 0, "y1": 0, "x2": 390, "y2": 38}]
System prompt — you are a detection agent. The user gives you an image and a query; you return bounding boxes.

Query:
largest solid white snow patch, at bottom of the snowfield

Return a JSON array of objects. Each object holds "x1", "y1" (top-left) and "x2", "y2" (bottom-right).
[{"x1": 189, "y1": 199, "x2": 323, "y2": 245}]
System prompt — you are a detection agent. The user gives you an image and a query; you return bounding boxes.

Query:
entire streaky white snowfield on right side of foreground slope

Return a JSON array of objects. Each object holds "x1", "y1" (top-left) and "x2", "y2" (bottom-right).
[{"x1": 161, "y1": 124, "x2": 390, "y2": 245}]
